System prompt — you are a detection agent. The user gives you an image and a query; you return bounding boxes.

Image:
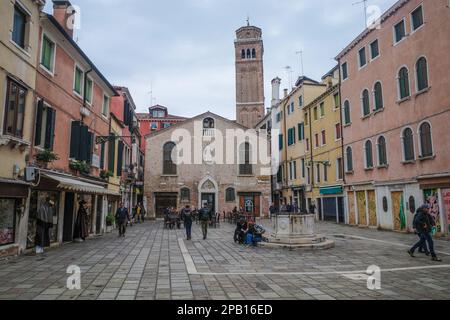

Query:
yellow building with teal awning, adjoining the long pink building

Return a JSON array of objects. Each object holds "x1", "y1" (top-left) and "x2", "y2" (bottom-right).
[{"x1": 303, "y1": 67, "x2": 344, "y2": 222}]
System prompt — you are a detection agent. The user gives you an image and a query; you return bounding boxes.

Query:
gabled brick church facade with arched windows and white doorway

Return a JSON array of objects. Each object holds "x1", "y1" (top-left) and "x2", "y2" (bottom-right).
[{"x1": 145, "y1": 112, "x2": 270, "y2": 218}]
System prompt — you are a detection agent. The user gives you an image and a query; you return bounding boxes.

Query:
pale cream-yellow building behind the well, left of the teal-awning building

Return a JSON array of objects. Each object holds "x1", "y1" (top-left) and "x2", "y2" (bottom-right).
[{"x1": 276, "y1": 77, "x2": 326, "y2": 212}]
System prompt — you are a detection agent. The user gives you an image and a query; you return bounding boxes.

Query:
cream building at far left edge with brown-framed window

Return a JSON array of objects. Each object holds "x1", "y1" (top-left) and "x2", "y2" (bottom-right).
[{"x1": 0, "y1": 0, "x2": 45, "y2": 256}]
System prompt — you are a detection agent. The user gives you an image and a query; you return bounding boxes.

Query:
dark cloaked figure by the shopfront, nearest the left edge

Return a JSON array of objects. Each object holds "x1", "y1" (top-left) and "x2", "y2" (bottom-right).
[{"x1": 35, "y1": 197, "x2": 55, "y2": 254}]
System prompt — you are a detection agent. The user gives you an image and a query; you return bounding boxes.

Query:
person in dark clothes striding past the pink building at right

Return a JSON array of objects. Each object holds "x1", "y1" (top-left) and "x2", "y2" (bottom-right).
[{"x1": 408, "y1": 206, "x2": 442, "y2": 262}]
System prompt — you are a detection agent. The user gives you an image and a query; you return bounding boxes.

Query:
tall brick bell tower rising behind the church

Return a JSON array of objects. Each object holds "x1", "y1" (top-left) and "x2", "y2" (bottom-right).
[{"x1": 234, "y1": 23, "x2": 265, "y2": 128}]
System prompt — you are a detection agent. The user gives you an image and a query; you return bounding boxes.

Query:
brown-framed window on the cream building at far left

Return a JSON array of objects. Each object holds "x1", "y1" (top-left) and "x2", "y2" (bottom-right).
[{"x1": 3, "y1": 78, "x2": 27, "y2": 139}]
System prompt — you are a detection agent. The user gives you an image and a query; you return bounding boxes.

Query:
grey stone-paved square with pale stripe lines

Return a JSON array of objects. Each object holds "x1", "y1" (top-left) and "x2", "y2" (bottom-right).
[{"x1": 0, "y1": 222, "x2": 450, "y2": 300}]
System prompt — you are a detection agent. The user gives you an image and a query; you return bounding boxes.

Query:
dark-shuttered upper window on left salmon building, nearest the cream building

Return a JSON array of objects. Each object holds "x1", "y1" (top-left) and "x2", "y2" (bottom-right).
[{"x1": 34, "y1": 99, "x2": 56, "y2": 150}]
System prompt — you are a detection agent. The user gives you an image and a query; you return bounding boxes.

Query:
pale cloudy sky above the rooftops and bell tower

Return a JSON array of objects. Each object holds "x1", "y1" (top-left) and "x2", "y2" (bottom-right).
[{"x1": 42, "y1": 0, "x2": 396, "y2": 119}]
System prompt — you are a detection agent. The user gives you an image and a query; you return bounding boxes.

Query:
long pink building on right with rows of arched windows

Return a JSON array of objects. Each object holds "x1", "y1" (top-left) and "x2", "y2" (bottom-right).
[{"x1": 337, "y1": 0, "x2": 450, "y2": 235}]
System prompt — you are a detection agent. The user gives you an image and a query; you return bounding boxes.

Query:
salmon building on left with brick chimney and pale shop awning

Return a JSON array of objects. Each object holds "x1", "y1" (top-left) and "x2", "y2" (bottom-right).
[{"x1": 27, "y1": 1, "x2": 119, "y2": 248}]
